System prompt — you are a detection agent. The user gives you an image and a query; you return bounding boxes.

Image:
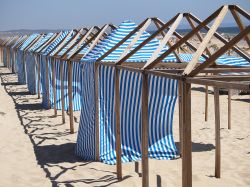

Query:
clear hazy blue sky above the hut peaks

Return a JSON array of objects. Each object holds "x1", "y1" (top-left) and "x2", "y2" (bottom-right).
[{"x1": 0, "y1": 0, "x2": 250, "y2": 31}]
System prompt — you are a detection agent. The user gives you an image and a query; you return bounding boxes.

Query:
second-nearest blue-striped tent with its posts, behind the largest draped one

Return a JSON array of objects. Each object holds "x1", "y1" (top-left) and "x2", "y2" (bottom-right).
[{"x1": 47, "y1": 24, "x2": 115, "y2": 133}]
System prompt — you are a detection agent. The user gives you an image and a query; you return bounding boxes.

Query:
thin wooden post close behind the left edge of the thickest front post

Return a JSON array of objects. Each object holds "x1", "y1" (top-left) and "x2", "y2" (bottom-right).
[{"x1": 178, "y1": 81, "x2": 183, "y2": 157}]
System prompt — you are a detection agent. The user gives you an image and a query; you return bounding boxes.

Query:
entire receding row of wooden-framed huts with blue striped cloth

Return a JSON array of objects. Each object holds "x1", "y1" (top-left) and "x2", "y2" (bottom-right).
[{"x1": 0, "y1": 5, "x2": 250, "y2": 187}]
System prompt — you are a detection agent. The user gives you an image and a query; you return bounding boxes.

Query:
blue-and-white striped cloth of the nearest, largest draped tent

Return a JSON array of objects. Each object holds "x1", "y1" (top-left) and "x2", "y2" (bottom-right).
[{"x1": 76, "y1": 21, "x2": 178, "y2": 164}]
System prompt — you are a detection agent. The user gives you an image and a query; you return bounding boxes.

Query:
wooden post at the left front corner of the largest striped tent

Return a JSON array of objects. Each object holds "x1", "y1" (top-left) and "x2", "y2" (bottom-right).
[{"x1": 95, "y1": 63, "x2": 100, "y2": 161}]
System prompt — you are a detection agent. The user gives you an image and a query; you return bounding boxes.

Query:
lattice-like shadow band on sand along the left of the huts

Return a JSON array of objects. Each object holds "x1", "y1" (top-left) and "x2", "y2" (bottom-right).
[{"x1": 0, "y1": 67, "x2": 127, "y2": 187}]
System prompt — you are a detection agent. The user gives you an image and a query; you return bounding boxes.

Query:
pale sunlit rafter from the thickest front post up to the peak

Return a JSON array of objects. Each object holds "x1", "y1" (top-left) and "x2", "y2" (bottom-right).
[{"x1": 183, "y1": 5, "x2": 228, "y2": 75}]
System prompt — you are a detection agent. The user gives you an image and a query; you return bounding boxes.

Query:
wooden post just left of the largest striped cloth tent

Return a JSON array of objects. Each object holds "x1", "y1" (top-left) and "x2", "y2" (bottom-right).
[{"x1": 67, "y1": 61, "x2": 74, "y2": 134}]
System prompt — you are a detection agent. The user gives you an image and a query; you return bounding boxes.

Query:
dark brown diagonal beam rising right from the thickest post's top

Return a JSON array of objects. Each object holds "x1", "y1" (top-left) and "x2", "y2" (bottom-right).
[{"x1": 188, "y1": 26, "x2": 250, "y2": 77}]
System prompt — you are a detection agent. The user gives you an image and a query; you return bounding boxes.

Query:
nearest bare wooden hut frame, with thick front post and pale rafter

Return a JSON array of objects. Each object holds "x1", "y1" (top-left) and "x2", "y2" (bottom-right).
[{"x1": 122, "y1": 5, "x2": 250, "y2": 187}]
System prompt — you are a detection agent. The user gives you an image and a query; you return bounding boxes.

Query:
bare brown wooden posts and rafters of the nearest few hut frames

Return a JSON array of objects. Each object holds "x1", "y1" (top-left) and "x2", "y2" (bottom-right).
[{"x1": 87, "y1": 5, "x2": 250, "y2": 187}]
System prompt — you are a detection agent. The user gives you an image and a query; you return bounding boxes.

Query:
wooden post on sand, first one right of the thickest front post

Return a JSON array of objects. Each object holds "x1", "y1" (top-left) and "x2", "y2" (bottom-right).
[{"x1": 214, "y1": 87, "x2": 221, "y2": 178}]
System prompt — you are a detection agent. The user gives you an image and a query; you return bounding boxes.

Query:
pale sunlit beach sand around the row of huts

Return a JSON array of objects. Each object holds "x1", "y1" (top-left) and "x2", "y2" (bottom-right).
[{"x1": 0, "y1": 63, "x2": 250, "y2": 187}]
